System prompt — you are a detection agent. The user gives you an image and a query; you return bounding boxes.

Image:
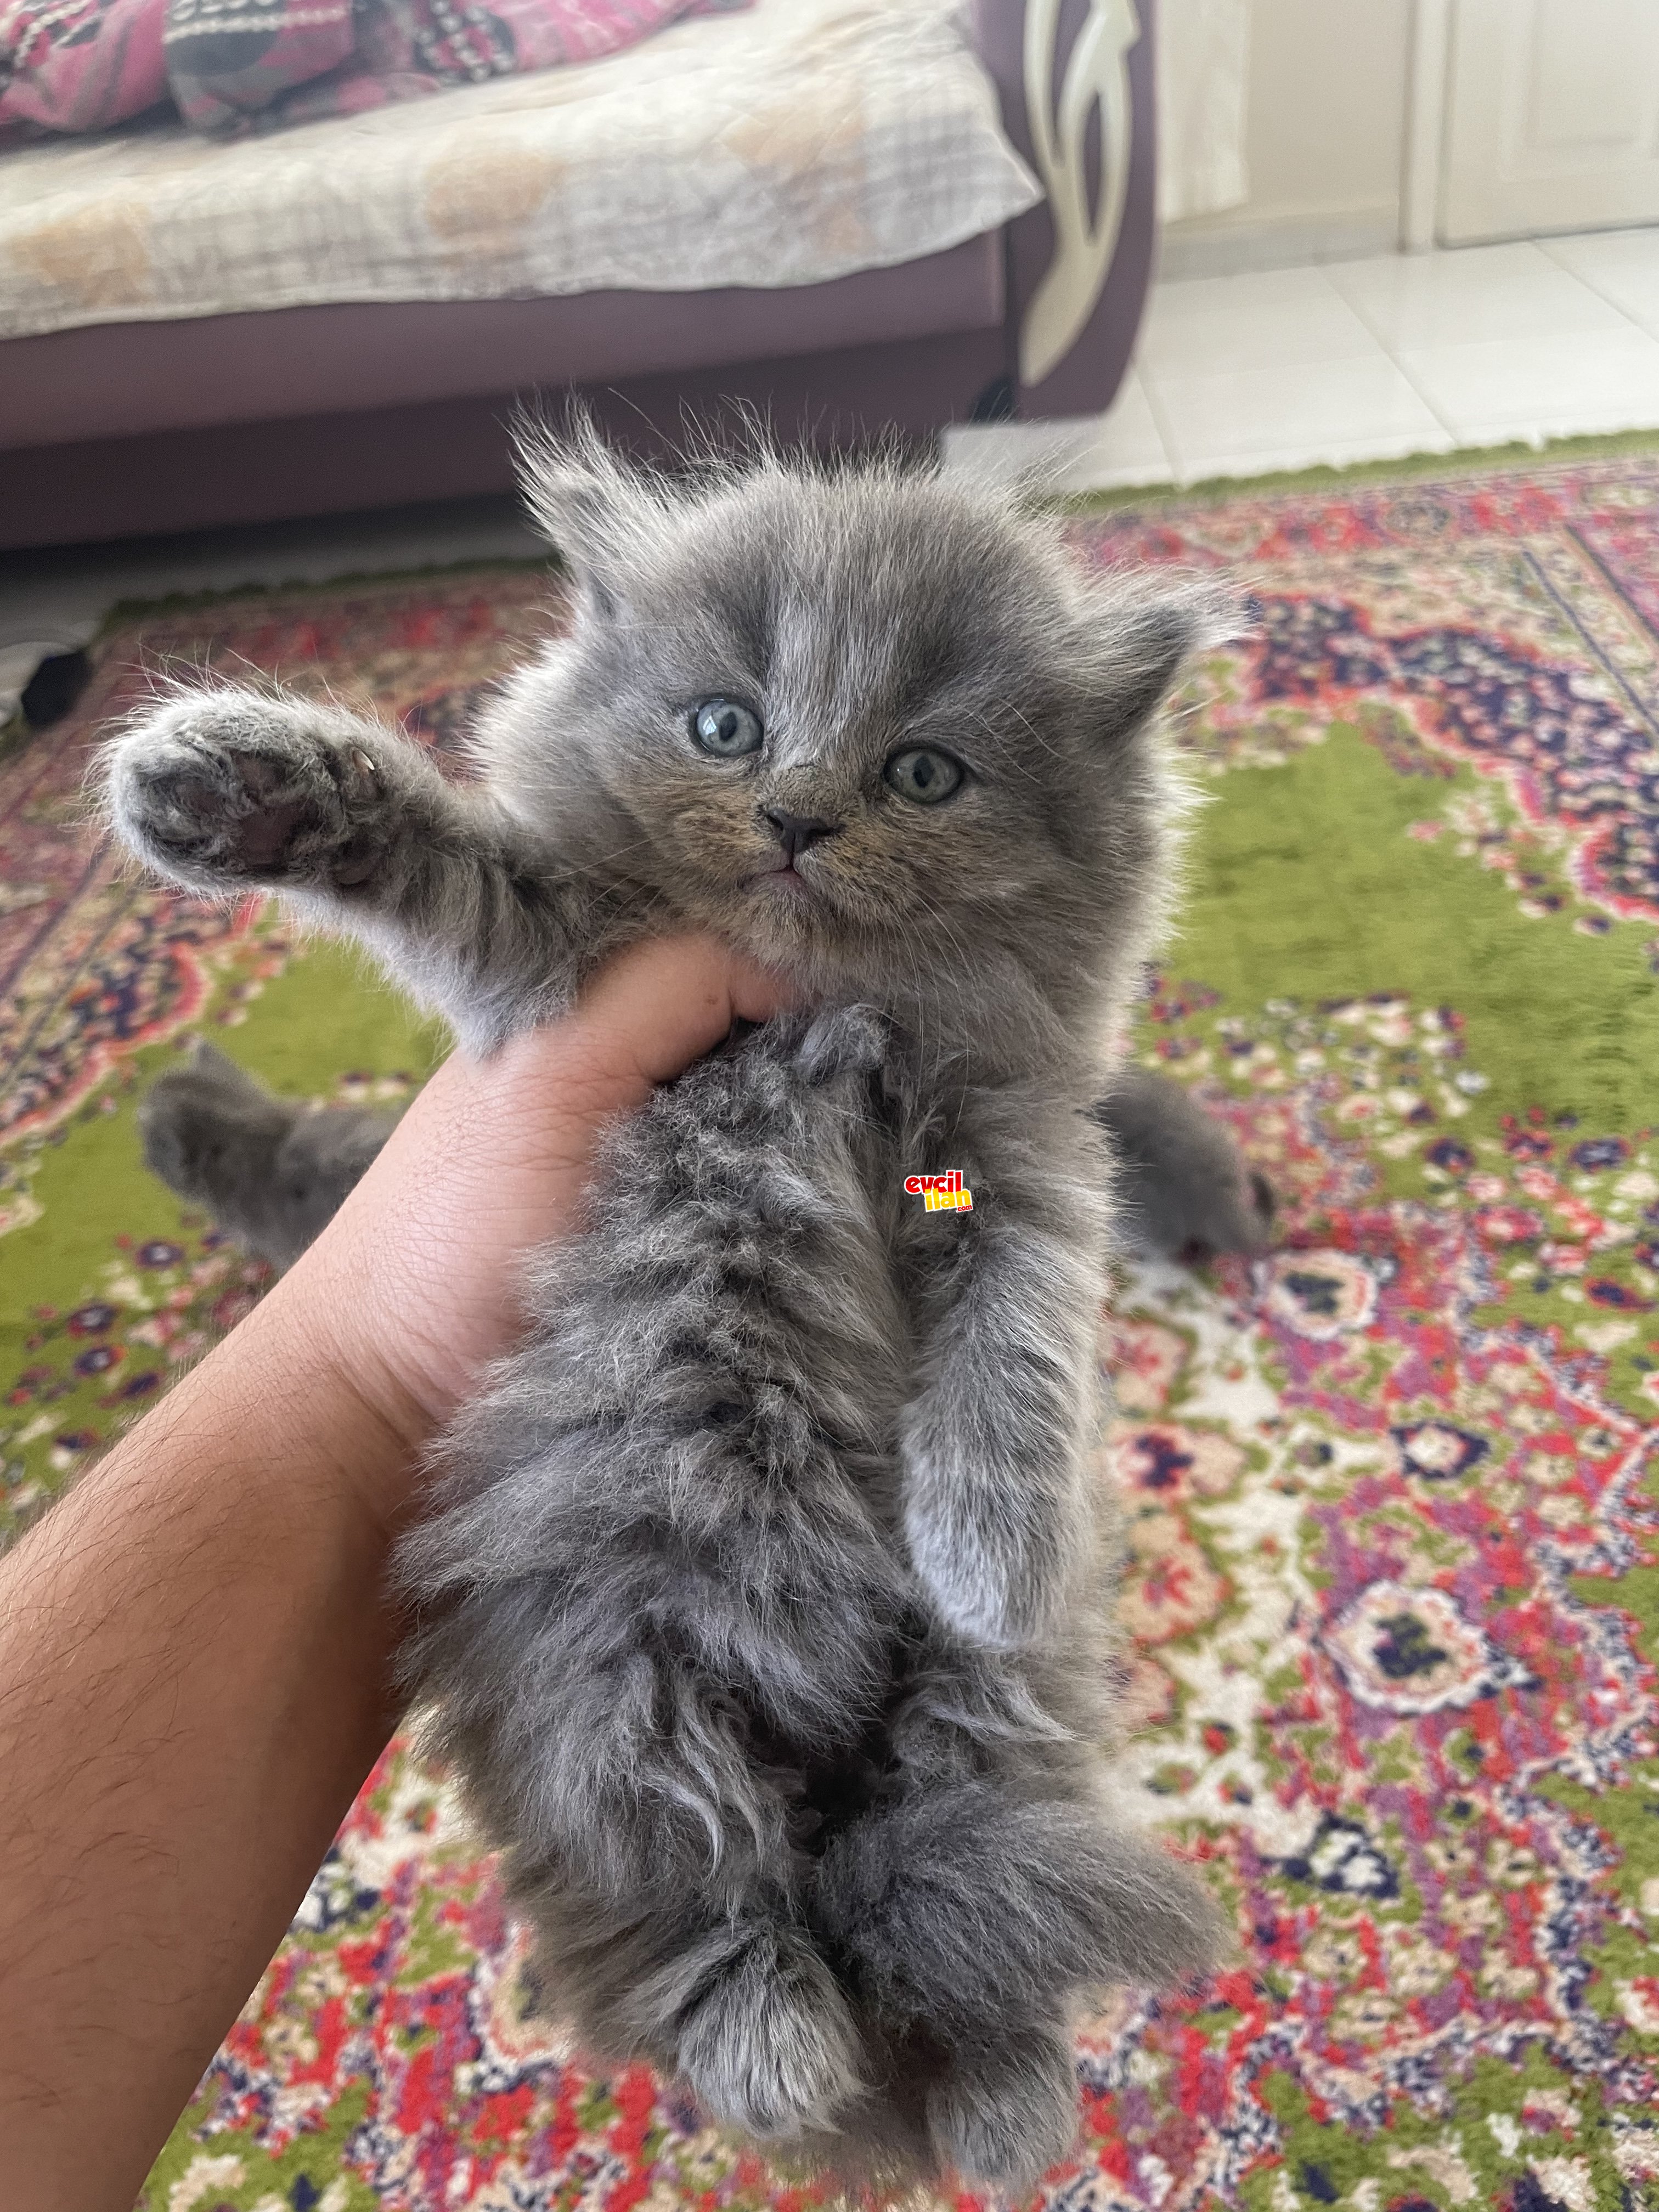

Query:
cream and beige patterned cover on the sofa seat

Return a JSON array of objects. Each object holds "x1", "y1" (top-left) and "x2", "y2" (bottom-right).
[{"x1": 0, "y1": 0, "x2": 1040, "y2": 336}]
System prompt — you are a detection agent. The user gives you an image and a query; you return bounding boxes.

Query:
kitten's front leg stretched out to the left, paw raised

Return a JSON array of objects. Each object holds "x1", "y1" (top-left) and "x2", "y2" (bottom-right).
[{"x1": 106, "y1": 688, "x2": 600, "y2": 1048}]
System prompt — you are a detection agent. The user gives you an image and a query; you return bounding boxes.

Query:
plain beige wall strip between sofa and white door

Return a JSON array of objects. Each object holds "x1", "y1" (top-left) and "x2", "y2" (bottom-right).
[{"x1": 1161, "y1": 0, "x2": 1411, "y2": 276}]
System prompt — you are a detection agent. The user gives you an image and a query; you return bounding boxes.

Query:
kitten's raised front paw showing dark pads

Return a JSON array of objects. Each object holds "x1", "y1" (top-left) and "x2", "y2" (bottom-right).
[{"x1": 109, "y1": 690, "x2": 392, "y2": 891}]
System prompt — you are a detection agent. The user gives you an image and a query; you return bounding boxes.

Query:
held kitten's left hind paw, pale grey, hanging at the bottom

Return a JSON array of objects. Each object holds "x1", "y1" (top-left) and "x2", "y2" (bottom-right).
[{"x1": 679, "y1": 1929, "x2": 860, "y2": 2139}]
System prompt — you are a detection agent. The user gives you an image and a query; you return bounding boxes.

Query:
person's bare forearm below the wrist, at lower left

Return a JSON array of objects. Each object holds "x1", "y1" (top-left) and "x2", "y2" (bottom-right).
[{"x1": 0, "y1": 1285, "x2": 407, "y2": 2212}]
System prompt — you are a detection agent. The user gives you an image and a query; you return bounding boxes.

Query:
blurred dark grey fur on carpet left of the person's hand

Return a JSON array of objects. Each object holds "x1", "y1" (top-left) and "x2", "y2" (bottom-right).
[{"x1": 139, "y1": 1044, "x2": 398, "y2": 1267}]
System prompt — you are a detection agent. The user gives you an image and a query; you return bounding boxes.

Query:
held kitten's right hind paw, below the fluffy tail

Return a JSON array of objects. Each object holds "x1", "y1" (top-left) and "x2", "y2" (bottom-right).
[{"x1": 927, "y1": 2030, "x2": 1077, "y2": 2197}]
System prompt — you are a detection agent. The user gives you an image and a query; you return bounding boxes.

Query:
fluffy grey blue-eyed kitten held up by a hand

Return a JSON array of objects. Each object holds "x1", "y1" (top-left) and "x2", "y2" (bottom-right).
[{"x1": 109, "y1": 438, "x2": 1263, "y2": 2190}]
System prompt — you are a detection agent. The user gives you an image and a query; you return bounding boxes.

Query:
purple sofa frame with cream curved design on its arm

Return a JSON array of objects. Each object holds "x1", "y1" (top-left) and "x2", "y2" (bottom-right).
[{"x1": 0, "y1": 0, "x2": 1155, "y2": 549}]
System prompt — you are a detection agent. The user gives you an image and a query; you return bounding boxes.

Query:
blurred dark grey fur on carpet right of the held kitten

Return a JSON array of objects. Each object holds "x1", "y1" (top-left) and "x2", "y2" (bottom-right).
[{"x1": 1095, "y1": 1064, "x2": 1274, "y2": 1259}]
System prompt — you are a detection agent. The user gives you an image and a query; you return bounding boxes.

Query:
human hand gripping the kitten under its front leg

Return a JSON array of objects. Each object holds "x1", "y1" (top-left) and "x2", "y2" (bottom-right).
[{"x1": 244, "y1": 936, "x2": 785, "y2": 1524}]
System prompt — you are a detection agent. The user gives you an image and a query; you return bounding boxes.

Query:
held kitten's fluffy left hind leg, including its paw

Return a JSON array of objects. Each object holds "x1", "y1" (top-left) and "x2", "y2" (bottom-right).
[{"x1": 400, "y1": 1557, "x2": 860, "y2": 2141}]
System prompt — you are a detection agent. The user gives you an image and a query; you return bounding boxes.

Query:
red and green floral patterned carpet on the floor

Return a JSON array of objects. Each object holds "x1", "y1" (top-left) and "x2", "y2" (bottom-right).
[{"x1": 0, "y1": 454, "x2": 1659, "y2": 2212}]
